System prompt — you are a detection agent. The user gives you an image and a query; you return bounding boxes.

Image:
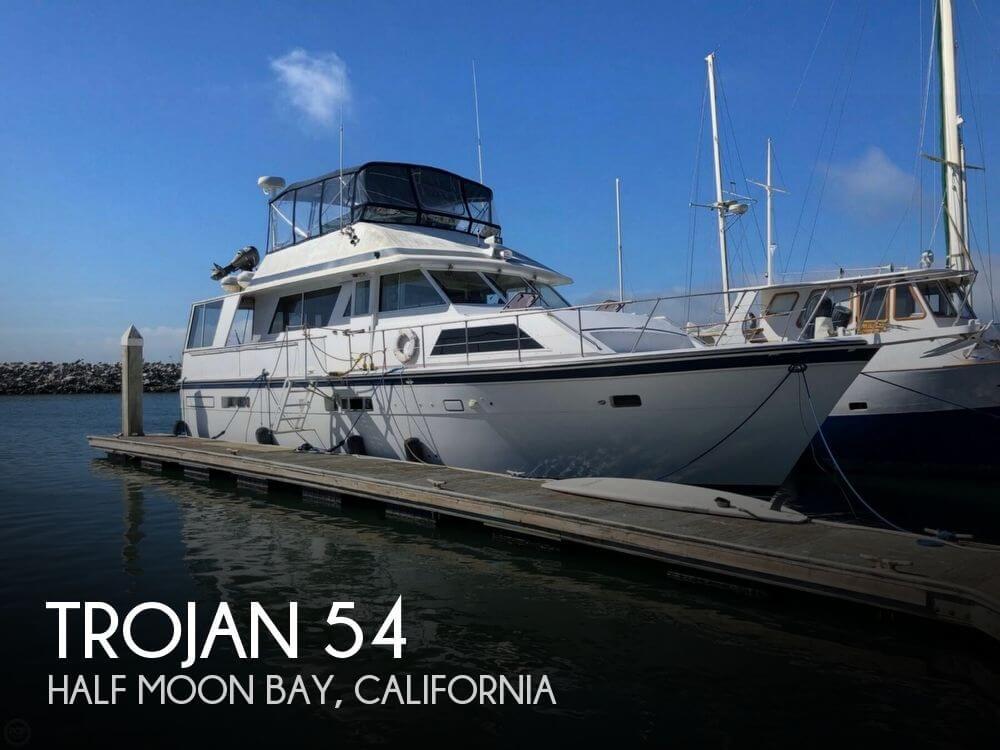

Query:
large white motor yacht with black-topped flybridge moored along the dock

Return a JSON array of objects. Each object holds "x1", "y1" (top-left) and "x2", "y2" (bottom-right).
[{"x1": 179, "y1": 162, "x2": 878, "y2": 489}]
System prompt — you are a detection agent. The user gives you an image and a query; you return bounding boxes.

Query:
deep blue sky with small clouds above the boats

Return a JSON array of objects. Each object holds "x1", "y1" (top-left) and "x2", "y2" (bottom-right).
[{"x1": 0, "y1": 0, "x2": 1000, "y2": 360}]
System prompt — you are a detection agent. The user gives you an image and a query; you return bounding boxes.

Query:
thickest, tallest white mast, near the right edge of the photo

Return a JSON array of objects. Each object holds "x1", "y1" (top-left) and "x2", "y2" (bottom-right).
[{"x1": 938, "y1": 0, "x2": 970, "y2": 271}]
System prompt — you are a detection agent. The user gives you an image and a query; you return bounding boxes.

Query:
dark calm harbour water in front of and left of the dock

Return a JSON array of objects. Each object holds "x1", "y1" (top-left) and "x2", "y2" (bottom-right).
[{"x1": 0, "y1": 394, "x2": 1000, "y2": 747}]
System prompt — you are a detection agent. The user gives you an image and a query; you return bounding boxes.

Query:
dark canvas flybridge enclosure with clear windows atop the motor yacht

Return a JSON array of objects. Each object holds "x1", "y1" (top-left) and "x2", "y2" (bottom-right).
[{"x1": 268, "y1": 162, "x2": 500, "y2": 252}]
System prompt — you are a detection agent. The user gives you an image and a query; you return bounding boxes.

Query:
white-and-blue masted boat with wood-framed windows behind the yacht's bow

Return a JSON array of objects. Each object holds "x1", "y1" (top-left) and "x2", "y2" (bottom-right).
[{"x1": 694, "y1": 0, "x2": 1000, "y2": 471}]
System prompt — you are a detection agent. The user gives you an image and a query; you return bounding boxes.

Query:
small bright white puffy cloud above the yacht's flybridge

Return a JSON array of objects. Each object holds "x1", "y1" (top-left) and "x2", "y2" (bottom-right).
[{"x1": 271, "y1": 49, "x2": 351, "y2": 125}]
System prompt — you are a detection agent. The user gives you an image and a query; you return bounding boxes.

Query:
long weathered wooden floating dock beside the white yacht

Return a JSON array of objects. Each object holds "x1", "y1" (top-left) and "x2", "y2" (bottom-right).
[{"x1": 87, "y1": 435, "x2": 1000, "y2": 639}]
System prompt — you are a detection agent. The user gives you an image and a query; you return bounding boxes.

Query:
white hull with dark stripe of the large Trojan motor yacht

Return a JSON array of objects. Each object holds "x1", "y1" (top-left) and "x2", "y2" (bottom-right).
[{"x1": 181, "y1": 345, "x2": 874, "y2": 489}]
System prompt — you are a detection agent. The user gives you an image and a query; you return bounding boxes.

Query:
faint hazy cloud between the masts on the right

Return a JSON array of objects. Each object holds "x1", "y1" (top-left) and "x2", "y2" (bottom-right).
[{"x1": 830, "y1": 146, "x2": 914, "y2": 221}]
